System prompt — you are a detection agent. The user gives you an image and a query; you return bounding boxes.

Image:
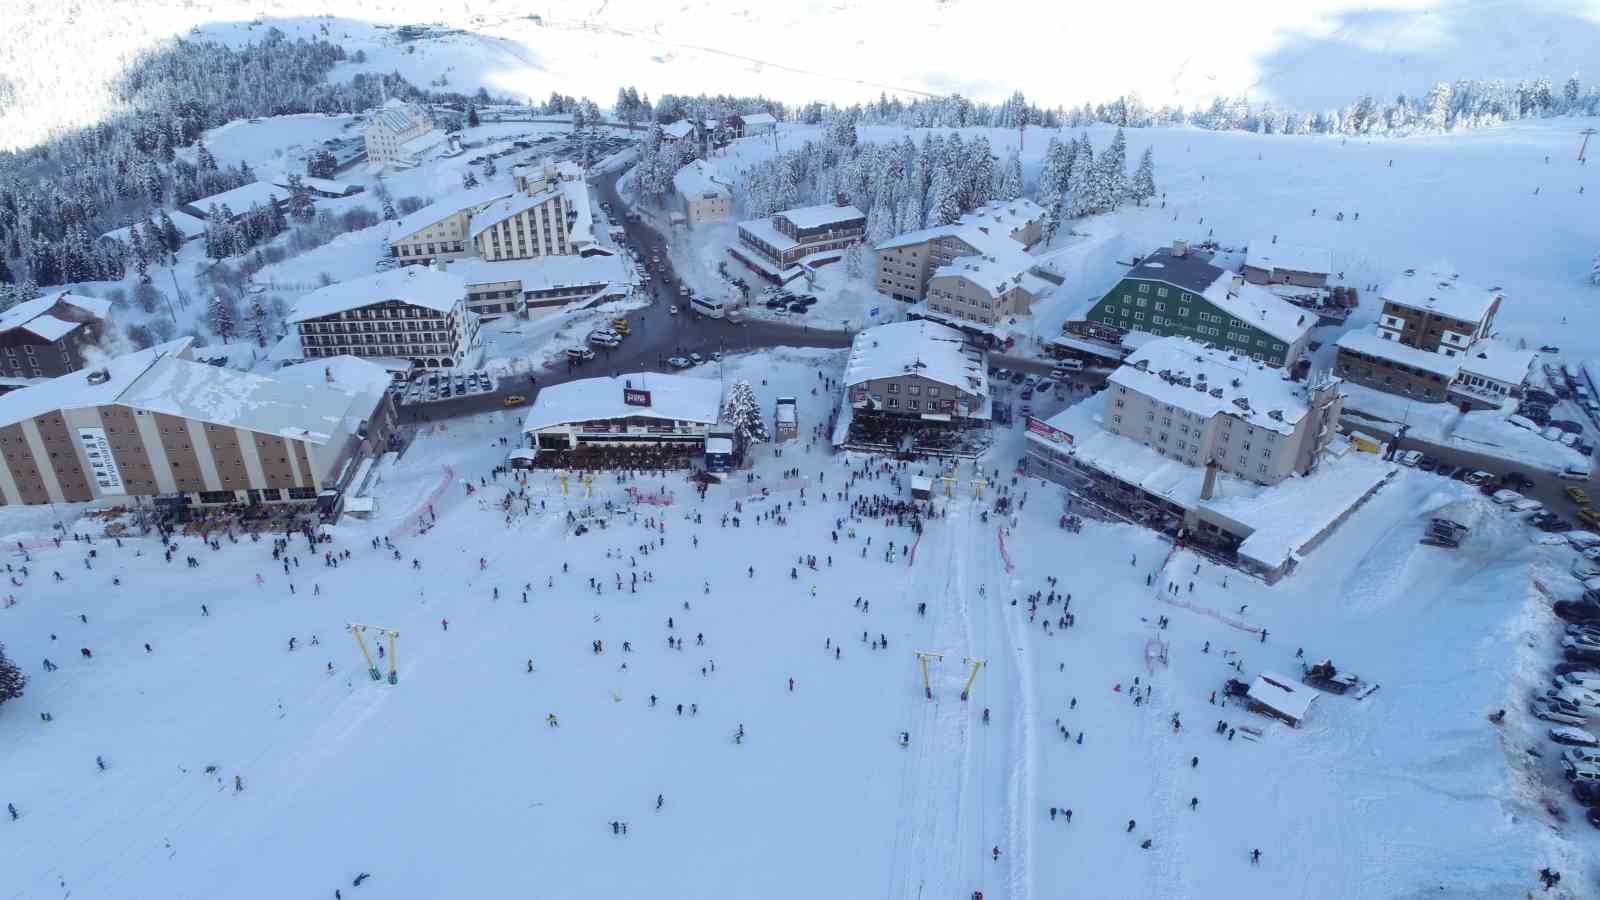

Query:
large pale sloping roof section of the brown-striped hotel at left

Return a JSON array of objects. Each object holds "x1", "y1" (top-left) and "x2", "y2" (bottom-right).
[{"x1": 117, "y1": 356, "x2": 354, "y2": 444}]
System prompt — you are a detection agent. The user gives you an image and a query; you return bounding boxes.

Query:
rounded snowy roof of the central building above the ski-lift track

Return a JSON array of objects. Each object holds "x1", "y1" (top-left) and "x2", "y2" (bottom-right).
[{"x1": 845, "y1": 319, "x2": 989, "y2": 397}]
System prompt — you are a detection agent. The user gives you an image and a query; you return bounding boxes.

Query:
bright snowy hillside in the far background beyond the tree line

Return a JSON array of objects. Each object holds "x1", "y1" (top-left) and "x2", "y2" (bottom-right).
[{"x1": 0, "y1": 0, "x2": 1600, "y2": 146}]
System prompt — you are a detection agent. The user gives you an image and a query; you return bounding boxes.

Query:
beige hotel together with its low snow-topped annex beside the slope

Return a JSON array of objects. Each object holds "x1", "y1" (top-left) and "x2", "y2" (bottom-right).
[{"x1": 1027, "y1": 338, "x2": 1395, "y2": 580}]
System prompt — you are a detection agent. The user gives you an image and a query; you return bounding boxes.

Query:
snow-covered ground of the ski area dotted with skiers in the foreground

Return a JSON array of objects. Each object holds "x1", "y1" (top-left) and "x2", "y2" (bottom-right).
[{"x1": 0, "y1": 351, "x2": 1597, "y2": 900}]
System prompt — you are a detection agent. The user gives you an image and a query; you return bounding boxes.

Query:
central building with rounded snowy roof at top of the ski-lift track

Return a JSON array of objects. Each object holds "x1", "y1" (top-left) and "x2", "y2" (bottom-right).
[{"x1": 843, "y1": 320, "x2": 990, "y2": 421}]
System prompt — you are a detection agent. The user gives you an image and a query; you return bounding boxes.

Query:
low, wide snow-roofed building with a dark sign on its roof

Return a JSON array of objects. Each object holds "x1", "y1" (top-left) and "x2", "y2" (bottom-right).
[{"x1": 522, "y1": 372, "x2": 722, "y2": 456}]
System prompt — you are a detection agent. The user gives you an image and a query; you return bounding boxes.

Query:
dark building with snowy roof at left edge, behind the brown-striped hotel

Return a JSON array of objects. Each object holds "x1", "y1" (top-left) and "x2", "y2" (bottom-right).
[{"x1": 0, "y1": 291, "x2": 110, "y2": 378}]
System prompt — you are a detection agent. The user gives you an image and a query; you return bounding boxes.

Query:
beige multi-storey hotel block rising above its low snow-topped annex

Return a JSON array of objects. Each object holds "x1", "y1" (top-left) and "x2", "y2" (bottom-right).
[{"x1": 1102, "y1": 336, "x2": 1344, "y2": 485}]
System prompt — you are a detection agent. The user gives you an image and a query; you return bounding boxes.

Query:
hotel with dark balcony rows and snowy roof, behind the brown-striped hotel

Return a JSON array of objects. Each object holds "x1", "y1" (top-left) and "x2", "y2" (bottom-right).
[{"x1": 288, "y1": 266, "x2": 478, "y2": 368}]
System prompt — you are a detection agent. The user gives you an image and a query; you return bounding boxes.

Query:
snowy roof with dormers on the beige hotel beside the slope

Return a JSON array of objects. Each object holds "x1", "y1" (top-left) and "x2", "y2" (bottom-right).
[{"x1": 1110, "y1": 338, "x2": 1306, "y2": 434}]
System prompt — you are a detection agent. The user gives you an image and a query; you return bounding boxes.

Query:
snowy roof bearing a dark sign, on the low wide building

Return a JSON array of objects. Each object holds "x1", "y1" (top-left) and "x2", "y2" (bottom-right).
[{"x1": 521, "y1": 372, "x2": 722, "y2": 432}]
